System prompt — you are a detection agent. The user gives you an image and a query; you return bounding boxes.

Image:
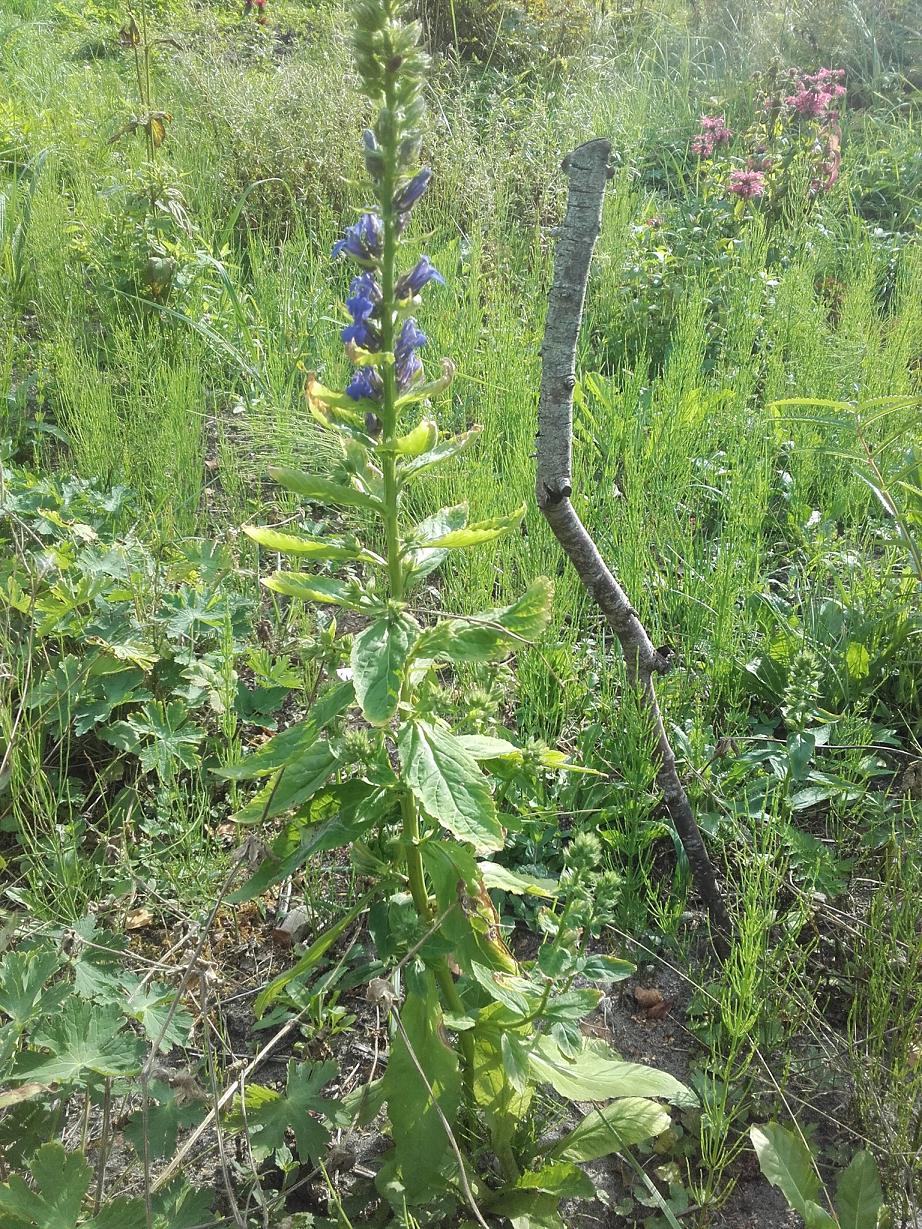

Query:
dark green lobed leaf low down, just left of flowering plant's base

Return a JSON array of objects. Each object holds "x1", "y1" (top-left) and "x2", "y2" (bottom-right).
[{"x1": 227, "y1": 1062, "x2": 341, "y2": 1165}]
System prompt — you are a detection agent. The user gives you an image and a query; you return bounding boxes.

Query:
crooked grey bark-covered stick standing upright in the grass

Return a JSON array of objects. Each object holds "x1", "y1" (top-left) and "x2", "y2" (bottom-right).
[{"x1": 536, "y1": 139, "x2": 731, "y2": 956}]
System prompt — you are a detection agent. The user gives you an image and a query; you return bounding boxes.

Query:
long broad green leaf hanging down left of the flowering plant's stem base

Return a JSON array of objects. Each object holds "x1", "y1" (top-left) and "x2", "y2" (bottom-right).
[{"x1": 384, "y1": 972, "x2": 461, "y2": 1203}]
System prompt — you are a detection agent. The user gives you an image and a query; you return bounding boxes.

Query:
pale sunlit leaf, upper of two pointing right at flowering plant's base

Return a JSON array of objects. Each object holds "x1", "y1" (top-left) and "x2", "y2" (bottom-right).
[{"x1": 531, "y1": 1037, "x2": 697, "y2": 1106}]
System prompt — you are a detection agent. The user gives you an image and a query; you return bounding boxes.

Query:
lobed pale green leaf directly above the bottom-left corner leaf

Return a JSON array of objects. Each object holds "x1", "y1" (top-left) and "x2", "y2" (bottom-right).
[{"x1": 15, "y1": 998, "x2": 141, "y2": 1084}]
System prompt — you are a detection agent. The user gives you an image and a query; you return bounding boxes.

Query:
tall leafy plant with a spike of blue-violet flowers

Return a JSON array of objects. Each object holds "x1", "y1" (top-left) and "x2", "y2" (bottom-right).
[{"x1": 224, "y1": 0, "x2": 691, "y2": 1227}]
